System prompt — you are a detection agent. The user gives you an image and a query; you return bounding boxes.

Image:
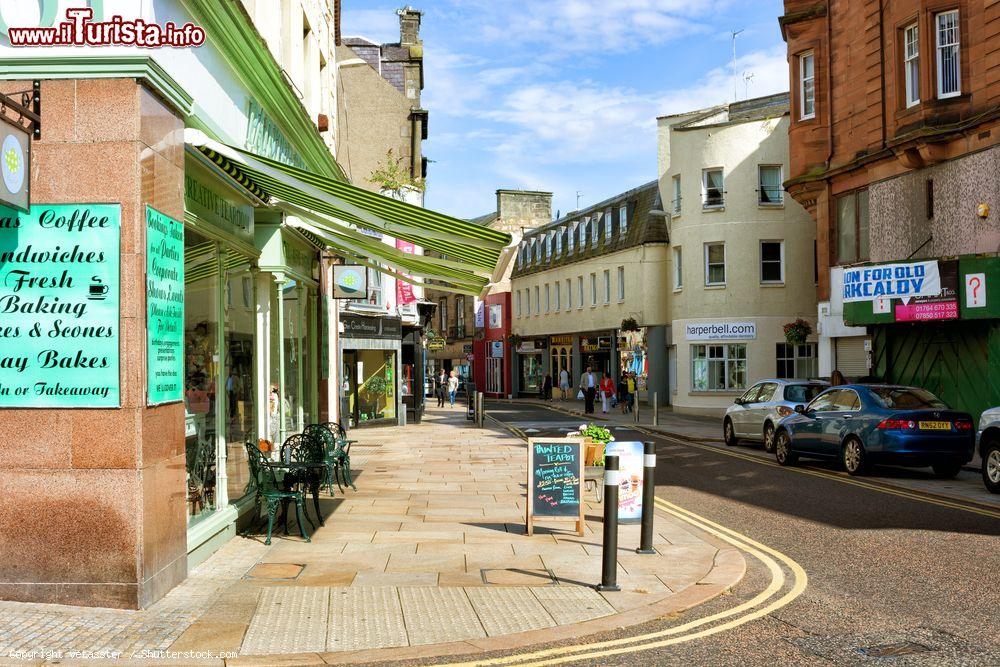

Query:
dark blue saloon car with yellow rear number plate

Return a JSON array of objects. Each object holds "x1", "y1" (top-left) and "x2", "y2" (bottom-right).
[{"x1": 774, "y1": 384, "x2": 975, "y2": 478}]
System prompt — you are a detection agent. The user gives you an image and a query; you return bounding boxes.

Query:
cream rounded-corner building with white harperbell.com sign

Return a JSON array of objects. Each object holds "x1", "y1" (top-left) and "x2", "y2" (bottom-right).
[{"x1": 658, "y1": 93, "x2": 817, "y2": 414}]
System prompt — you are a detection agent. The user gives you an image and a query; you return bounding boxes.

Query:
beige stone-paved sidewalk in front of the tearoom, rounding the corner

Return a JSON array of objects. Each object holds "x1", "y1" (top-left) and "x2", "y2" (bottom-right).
[{"x1": 0, "y1": 408, "x2": 746, "y2": 664}]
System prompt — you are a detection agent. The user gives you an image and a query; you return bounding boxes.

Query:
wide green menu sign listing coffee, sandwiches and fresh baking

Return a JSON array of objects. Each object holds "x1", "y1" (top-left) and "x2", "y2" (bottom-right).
[{"x1": 0, "y1": 204, "x2": 121, "y2": 408}]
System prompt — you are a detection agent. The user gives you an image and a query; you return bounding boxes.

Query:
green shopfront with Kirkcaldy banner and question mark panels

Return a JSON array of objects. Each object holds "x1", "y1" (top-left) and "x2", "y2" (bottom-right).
[{"x1": 833, "y1": 254, "x2": 1000, "y2": 420}]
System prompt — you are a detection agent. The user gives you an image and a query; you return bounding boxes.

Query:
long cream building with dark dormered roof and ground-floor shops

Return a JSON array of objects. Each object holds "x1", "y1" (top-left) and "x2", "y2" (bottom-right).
[{"x1": 510, "y1": 182, "x2": 669, "y2": 403}]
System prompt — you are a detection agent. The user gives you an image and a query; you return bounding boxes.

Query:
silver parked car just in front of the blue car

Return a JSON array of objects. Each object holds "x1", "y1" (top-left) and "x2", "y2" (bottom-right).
[{"x1": 722, "y1": 380, "x2": 830, "y2": 453}]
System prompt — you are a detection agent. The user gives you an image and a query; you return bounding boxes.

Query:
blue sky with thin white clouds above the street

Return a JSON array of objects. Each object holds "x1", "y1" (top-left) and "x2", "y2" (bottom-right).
[{"x1": 342, "y1": 0, "x2": 788, "y2": 218}]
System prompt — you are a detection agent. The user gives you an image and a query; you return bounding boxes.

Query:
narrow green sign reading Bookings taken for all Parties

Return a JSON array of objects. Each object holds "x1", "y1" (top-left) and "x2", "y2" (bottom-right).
[{"x1": 146, "y1": 206, "x2": 184, "y2": 405}]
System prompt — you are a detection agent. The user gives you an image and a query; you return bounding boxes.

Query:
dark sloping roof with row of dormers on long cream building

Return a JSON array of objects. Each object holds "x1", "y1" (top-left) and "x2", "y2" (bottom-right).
[{"x1": 512, "y1": 181, "x2": 669, "y2": 277}]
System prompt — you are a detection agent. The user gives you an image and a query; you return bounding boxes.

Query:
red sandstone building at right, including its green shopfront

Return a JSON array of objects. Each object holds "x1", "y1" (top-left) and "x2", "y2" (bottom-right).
[{"x1": 780, "y1": 0, "x2": 1000, "y2": 415}]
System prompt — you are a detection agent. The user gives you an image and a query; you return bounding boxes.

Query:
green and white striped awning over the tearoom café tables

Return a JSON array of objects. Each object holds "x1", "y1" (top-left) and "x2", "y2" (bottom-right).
[{"x1": 185, "y1": 130, "x2": 511, "y2": 294}]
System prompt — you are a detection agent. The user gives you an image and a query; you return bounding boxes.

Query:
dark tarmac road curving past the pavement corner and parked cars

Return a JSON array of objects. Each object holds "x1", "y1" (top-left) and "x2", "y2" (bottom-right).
[{"x1": 466, "y1": 403, "x2": 1000, "y2": 665}]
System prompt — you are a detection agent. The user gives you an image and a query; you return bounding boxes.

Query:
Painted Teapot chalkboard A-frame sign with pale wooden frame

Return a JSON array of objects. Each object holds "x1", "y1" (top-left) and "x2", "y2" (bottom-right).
[{"x1": 525, "y1": 438, "x2": 584, "y2": 535}]
